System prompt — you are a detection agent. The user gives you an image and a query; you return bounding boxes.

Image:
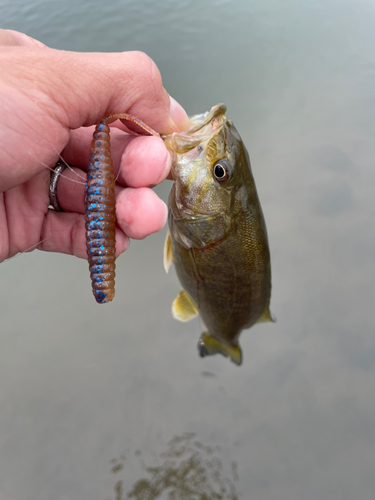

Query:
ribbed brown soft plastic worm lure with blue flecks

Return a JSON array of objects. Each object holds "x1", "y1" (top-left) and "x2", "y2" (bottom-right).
[{"x1": 85, "y1": 113, "x2": 160, "y2": 304}]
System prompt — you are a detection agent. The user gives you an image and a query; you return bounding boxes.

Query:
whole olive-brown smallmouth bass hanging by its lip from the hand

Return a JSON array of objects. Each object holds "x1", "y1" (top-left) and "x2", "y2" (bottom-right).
[{"x1": 163, "y1": 104, "x2": 273, "y2": 365}]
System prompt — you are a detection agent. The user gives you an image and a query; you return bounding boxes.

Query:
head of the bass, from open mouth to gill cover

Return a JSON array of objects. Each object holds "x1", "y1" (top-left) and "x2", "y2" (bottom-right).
[{"x1": 163, "y1": 104, "x2": 251, "y2": 247}]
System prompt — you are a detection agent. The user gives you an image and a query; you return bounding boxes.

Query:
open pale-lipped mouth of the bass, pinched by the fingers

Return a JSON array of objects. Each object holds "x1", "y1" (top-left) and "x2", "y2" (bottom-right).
[{"x1": 162, "y1": 104, "x2": 227, "y2": 155}]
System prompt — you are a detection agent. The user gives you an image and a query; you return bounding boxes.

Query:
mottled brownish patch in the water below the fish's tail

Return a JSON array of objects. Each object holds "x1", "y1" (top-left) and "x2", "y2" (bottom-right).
[{"x1": 111, "y1": 433, "x2": 239, "y2": 500}]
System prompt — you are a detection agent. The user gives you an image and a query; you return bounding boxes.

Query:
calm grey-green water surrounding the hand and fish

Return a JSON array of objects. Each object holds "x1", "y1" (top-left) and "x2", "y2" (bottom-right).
[{"x1": 0, "y1": 0, "x2": 375, "y2": 500}]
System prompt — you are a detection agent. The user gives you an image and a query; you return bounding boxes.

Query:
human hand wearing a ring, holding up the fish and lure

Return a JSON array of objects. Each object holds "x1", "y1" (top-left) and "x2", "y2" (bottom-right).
[{"x1": 0, "y1": 30, "x2": 189, "y2": 262}]
